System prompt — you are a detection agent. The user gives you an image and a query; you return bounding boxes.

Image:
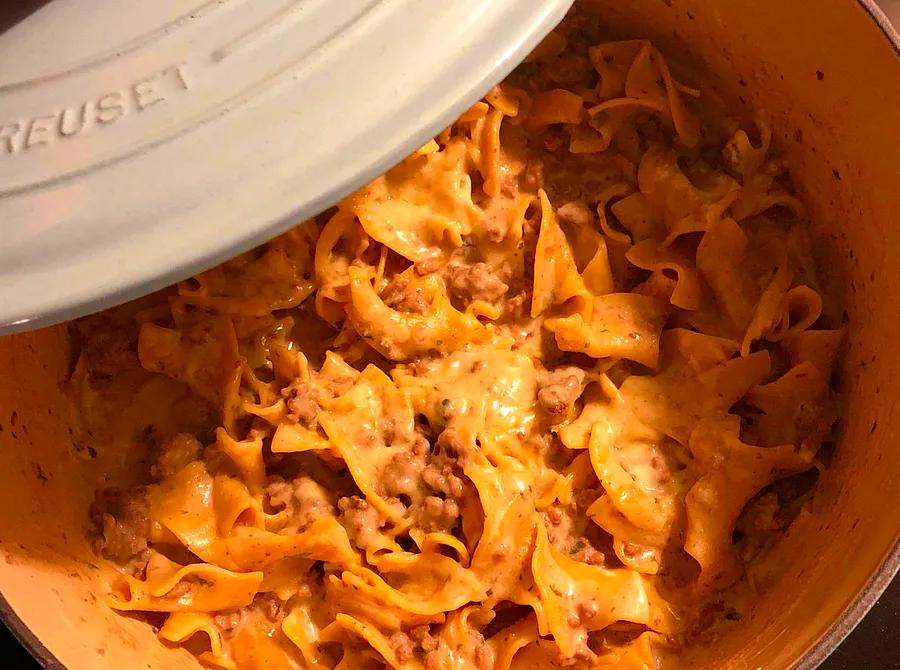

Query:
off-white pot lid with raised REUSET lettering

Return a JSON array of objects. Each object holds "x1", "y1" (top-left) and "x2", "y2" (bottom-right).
[{"x1": 0, "y1": 0, "x2": 572, "y2": 333}]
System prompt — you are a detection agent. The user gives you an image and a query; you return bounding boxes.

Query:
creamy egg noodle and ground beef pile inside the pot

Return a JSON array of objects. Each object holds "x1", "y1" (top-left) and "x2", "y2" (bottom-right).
[{"x1": 72, "y1": 14, "x2": 841, "y2": 670}]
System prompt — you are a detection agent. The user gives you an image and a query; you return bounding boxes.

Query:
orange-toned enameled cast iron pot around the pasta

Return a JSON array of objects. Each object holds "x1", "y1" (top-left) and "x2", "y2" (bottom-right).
[{"x1": 0, "y1": 0, "x2": 900, "y2": 670}]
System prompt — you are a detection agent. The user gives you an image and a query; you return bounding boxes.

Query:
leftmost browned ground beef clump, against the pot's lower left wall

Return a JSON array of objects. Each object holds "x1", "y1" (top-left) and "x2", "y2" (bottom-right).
[{"x1": 91, "y1": 488, "x2": 150, "y2": 565}]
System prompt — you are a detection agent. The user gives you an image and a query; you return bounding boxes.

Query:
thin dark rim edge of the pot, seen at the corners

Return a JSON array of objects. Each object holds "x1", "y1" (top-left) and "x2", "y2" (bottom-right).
[{"x1": 0, "y1": 0, "x2": 900, "y2": 670}]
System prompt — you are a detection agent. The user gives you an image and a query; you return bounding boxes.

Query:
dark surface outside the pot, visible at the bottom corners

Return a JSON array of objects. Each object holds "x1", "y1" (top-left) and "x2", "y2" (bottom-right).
[{"x1": 0, "y1": 576, "x2": 900, "y2": 670}]
